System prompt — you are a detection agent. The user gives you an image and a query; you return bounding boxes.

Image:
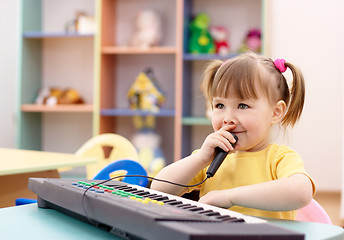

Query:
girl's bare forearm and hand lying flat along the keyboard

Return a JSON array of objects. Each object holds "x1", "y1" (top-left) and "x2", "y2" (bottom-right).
[{"x1": 199, "y1": 174, "x2": 313, "y2": 211}]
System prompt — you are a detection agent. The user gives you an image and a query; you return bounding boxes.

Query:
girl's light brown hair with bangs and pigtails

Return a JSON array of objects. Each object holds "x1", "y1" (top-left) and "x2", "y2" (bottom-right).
[{"x1": 201, "y1": 53, "x2": 305, "y2": 128}]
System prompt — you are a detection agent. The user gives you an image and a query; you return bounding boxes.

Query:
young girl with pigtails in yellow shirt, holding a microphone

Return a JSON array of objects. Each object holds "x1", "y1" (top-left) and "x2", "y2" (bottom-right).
[{"x1": 151, "y1": 53, "x2": 315, "y2": 219}]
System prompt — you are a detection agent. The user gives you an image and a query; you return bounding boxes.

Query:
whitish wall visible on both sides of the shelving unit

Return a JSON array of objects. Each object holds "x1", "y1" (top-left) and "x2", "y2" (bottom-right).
[{"x1": 0, "y1": 0, "x2": 344, "y2": 195}]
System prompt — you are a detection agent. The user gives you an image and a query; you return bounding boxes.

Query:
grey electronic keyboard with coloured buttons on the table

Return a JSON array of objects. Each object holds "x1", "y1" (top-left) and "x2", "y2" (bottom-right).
[{"x1": 29, "y1": 178, "x2": 304, "y2": 240}]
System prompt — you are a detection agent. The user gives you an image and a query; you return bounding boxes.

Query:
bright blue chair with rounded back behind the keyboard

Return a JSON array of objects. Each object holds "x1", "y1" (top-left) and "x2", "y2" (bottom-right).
[{"x1": 15, "y1": 159, "x2": 148, "y2": 206}]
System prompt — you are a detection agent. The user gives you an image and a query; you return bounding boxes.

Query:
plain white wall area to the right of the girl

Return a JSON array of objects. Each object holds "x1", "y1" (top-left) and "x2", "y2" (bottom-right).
[{"x1": 268, "y1": 0, "x2": 344, "y2": 191}]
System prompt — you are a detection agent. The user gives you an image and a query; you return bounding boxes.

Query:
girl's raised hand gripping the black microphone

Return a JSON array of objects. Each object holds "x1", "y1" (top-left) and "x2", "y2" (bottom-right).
[{"x1": 196, "y1": 126, "x2": 235, "y2": 164}]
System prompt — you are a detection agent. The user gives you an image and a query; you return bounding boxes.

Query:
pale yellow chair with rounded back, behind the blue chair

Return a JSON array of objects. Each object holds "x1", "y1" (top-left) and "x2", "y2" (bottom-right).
[{"x1": 75, "y1": 133, "x2": 138, "y2": 179}]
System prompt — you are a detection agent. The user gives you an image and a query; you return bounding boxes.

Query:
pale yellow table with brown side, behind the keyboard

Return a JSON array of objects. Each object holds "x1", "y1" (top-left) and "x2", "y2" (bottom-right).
[{"x1": 0, "y1": 148, "x2": 97, "y2": 208}]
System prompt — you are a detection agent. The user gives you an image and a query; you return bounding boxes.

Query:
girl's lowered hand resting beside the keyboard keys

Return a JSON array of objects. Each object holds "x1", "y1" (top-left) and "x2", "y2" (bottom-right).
[{"x1": 199, "y1": 189, "x2": 234, "y2": 208}]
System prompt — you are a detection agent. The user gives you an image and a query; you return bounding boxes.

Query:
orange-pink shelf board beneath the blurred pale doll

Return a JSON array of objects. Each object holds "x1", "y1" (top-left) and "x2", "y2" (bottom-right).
[{"x1": 102, "y1": 46, "x2": 177, "y2": 54}]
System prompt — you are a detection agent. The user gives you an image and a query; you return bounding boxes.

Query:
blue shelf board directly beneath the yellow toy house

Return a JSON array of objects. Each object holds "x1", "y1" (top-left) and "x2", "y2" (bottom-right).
[{"x1": 100, "y1": 108, "x2": 175, "y2": 117}]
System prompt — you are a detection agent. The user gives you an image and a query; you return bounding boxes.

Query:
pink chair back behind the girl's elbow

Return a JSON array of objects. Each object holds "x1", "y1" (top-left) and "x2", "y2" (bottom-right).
[{"x1": 296, "y1": 199, "x2": 332, "y2": 224}]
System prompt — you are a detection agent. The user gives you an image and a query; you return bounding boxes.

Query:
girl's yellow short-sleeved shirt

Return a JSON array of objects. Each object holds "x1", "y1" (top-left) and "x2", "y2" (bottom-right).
[{"x1": 189, "y1": 144, "x2": 315, "y2": 220}]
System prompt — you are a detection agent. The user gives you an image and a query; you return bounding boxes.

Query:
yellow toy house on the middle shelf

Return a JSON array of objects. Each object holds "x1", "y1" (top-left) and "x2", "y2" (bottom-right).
[{"x1": 128, "y1": 68, "x2": 165, "y2": 112}]
